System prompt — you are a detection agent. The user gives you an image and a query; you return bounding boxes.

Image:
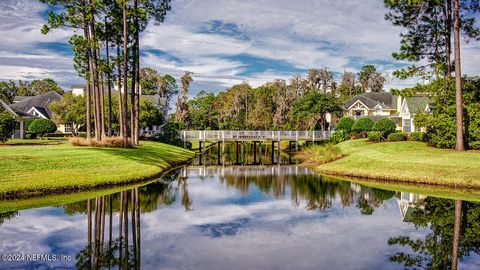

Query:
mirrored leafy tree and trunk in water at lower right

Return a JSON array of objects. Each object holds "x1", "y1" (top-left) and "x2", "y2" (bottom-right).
[{"x1": 388, "y1": 198, "x2": 480, "y2": 269}]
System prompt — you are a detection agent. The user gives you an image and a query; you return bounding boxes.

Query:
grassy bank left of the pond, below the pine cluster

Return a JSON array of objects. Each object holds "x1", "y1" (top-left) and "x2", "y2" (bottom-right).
[{"x1": 0, "y1": 142, "x2": 194, "y2": 198}]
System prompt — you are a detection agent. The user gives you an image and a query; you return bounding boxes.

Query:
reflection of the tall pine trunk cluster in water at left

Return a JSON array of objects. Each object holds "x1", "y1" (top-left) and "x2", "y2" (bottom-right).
[{"x1": 76, "y1": 188, "x2": 141, "y2": 269}]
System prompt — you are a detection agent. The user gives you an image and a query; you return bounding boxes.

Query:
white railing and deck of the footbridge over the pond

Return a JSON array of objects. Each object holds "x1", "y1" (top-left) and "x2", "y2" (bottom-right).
[{"x1": 181, "y1": 130, "x2": 331, "y2": 141}]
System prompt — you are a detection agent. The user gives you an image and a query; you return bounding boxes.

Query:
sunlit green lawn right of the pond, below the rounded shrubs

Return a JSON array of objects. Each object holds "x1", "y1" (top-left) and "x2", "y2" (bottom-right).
[{"x1": 315, "y1": 140, "x2": 480, "y2": 188}]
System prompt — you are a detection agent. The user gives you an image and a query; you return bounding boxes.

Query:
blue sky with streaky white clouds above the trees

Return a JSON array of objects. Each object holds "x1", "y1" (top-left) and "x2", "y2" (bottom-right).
[{"x1": 0, "y1": 0, "x2": 480, "y2": 95}]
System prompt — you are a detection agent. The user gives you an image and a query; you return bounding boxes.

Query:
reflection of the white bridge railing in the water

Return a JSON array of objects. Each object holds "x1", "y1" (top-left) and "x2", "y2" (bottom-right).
[{"x1": 182, "y1": 165, "x2": 314, "y2": 177}]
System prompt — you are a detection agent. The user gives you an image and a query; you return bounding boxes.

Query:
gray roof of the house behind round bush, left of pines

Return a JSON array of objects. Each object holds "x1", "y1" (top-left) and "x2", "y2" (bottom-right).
[{"x1": 9, "y1": 91, "x2": 62, "y2": 118}]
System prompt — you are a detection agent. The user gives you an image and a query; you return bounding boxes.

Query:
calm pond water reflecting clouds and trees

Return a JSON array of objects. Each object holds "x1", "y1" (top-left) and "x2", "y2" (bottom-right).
[{"x1": 0, "y1": 142, "x2": 480, "y2": 269}]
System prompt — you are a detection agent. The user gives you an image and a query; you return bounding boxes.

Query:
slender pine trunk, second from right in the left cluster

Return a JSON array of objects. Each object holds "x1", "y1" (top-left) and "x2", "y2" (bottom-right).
[{"x1": 122, "y1": 2, "x2": 128, "y2": 147}]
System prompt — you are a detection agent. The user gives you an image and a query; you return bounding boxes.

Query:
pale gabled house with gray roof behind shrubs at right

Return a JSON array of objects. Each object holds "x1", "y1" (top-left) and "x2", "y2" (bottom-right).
[{"x1": 344, "y1": 92, "x2": 430, "y2": 132}]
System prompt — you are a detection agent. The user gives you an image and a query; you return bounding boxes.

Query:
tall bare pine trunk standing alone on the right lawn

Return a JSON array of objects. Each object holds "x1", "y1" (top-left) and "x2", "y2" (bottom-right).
[{"x1": 453, "y1": 0, "x2": 465, "y2": 151}]
